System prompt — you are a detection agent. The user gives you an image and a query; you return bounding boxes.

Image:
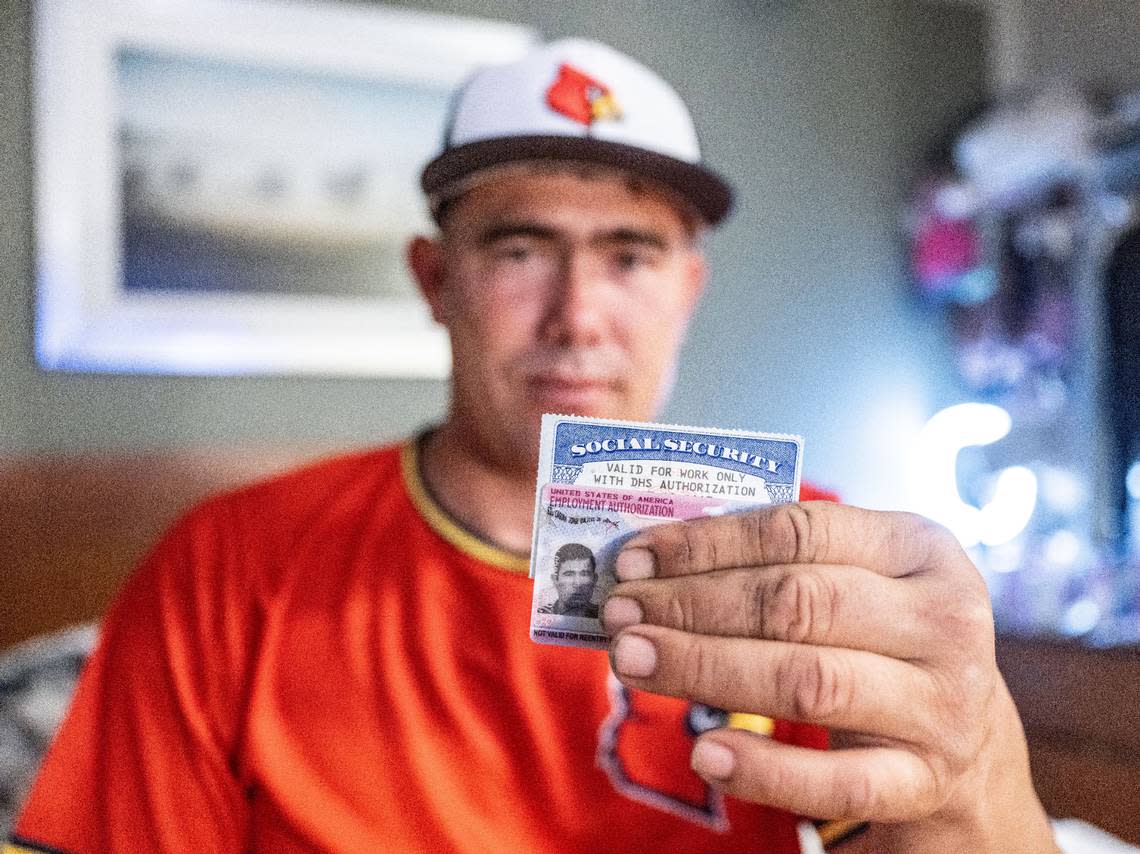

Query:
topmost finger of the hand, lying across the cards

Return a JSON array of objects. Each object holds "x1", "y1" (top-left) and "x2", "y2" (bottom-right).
[{"x1": 616, "y1": 502, "x2": 977, "y2": 581}]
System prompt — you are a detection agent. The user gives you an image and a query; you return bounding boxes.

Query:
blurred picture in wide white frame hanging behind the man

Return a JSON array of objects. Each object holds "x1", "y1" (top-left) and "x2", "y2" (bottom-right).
[{"x1": 34, "y1": 0, "x2": 535, "y2": 376}]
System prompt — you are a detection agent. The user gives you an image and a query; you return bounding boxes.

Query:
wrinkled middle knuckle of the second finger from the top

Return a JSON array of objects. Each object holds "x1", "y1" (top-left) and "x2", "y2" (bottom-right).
[{"x1": 752, "y1": 571, "x2": 837, "y2": 643}]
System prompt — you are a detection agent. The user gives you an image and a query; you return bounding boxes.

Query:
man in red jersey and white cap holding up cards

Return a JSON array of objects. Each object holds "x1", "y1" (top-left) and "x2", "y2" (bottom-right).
[{"x1": 16, "y1": 41, "x2": 1055, "y2": 854}]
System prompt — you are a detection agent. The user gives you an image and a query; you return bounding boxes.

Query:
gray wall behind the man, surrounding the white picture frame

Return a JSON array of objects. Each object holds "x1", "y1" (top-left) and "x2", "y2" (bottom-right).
[{"x1": 0, "y1": 0, "x2": 984, "y2": 505}]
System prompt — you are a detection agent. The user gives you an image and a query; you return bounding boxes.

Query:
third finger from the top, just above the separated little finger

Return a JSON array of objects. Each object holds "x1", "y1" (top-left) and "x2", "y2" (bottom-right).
[{"x1": 610, "y1": 626, "x2": 941, "y2": 743}]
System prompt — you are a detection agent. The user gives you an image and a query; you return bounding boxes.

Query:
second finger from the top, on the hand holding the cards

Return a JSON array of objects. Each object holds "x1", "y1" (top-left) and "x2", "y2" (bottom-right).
[{"x1": 602, "y1": 564, "x2": 941, "y2": 659}]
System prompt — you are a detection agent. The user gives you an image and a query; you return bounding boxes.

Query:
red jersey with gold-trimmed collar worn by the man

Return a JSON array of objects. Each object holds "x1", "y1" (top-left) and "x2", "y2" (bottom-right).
[{"x1": 13, "y1": 444, "x2": 839, "y2": 854}]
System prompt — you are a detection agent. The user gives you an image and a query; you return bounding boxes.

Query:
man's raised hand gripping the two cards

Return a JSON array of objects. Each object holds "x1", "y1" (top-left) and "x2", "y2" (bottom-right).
[{"x1": 603, "y1": 502, "x2": 1057, "y2": 854}]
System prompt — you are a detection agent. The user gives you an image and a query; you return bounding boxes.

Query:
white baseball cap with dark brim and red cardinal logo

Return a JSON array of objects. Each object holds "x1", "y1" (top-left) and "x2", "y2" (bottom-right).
[{"x1": 421, "y1": 39, "x2": 732, "y2": 225}]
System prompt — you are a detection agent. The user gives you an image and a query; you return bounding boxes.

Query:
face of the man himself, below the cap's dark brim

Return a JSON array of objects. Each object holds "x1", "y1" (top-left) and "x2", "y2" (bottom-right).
[{"x1": 409, "y1": 170, "x2": 705, "y2": 469}]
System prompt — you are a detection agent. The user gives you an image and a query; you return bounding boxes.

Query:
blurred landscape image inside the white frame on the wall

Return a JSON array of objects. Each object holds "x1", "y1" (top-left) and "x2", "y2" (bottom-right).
[{"x1": 115, "y1": 50, "x2": 433, "y2": 299}]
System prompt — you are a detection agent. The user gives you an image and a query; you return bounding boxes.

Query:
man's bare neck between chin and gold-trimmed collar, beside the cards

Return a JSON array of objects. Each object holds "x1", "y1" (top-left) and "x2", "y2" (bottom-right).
[{"x1": 421, "y1": 422, "x2": 535, "y2": 554}]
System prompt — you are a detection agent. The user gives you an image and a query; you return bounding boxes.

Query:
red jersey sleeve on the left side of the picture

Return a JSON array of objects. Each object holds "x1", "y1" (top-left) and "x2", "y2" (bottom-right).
[{"x1": 13, "y1": 501, "x2": 258, "y2": 854}]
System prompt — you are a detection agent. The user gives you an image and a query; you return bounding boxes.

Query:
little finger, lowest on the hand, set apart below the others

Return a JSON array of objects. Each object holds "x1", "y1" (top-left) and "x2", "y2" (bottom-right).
[{"x1": 691, "y1": 730, "x2": 942, "y2": 821}]
